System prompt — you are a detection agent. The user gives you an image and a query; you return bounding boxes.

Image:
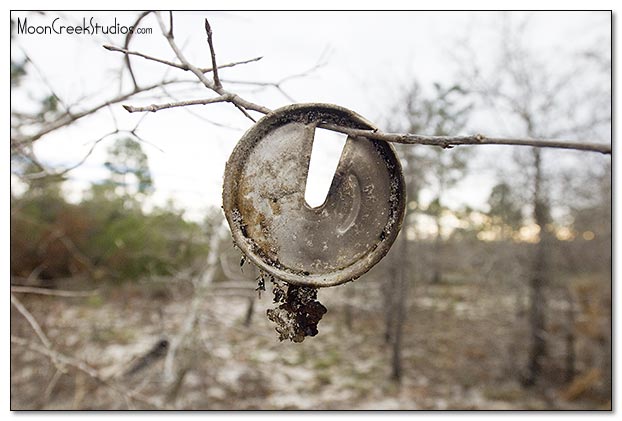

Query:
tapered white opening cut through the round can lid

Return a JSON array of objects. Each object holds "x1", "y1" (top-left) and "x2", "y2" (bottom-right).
[{"x1": 305, "y1": 129, "x2": 347, "y2": 208}]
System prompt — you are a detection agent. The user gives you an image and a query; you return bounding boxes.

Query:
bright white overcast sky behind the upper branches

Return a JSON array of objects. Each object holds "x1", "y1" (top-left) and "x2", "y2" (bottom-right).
[{"x1": 12, "y1": 12, "x2": 609, "y2": 219}]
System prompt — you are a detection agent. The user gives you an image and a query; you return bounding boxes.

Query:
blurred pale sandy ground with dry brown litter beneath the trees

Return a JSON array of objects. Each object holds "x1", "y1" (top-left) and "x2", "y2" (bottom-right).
[{"x1": 11, "y1": 281, "x2": 610, "y2": 410}]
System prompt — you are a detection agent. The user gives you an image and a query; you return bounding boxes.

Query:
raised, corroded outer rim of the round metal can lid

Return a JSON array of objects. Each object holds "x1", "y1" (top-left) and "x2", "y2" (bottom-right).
[{"x1": 223, "y1": 103, "x2": 406, "y2": 288}]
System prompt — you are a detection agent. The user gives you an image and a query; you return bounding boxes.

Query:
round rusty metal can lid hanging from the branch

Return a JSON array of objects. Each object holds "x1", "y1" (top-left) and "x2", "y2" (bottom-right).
[{"x1": 223, "y1": 104, "x2": 405, "y2": 288}]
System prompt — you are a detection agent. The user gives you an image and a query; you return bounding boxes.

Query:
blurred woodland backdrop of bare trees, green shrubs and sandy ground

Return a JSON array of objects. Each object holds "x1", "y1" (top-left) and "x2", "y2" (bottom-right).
[{"x1": 10, "y1": 14, "x2": 612, "y2": 409}]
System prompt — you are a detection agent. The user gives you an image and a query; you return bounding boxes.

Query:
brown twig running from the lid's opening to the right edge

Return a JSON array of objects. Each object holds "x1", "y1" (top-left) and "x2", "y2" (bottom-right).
[{"x1": 318, "y1": 124, "x2": 611, "y2": 155}]
